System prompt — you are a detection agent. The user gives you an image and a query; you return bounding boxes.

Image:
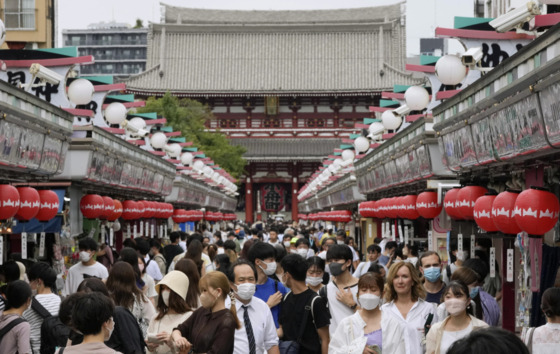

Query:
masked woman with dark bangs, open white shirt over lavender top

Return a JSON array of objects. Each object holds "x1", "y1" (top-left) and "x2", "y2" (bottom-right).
[{"x1": 329, "y1": 273, "x2": 405, "y2": 354}]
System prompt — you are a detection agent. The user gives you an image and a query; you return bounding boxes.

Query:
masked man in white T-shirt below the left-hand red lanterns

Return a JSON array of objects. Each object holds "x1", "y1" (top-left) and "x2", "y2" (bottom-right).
[{"x1": 62, "y1": 237, "x2": 109, "y2": 296}]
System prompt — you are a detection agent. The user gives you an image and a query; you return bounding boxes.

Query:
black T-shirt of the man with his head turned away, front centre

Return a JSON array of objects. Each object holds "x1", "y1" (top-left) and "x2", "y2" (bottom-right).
[{"x1": 279, "y1": 288, "x2": 331, "y2": 354}]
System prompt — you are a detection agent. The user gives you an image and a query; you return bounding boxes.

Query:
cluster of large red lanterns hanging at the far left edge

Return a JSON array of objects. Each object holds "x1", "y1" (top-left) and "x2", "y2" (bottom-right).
[{"x1": 0, "y1": 184, "x2": 60, "y2": 221}]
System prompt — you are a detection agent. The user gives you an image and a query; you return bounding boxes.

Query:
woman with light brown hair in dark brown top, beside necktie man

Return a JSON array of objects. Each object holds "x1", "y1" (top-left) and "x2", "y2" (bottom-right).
[{"x1": 171, "y1": 272, "x2": 241, "y2": 354}]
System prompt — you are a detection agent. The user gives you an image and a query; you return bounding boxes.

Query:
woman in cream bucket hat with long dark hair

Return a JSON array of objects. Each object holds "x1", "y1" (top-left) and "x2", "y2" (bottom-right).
[{"x1": 146, "y1": 270, "x2": 192, "y2": 354}]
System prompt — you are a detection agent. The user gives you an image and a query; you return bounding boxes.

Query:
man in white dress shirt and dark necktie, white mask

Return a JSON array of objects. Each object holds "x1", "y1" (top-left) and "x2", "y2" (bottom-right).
[{"x1": 228, "y1": 260, "x2": 280, "y2": 354}]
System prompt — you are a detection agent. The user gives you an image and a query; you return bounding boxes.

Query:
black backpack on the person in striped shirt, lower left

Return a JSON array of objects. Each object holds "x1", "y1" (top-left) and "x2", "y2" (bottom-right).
[{"x1": 31, "y1": 298, "x2": 70, "y2": 354}]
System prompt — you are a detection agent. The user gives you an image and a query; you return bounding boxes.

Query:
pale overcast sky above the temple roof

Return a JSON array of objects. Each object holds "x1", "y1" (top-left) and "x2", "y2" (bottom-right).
[{"x1": 57, "y1": 0, "x2": 472, "y2": 54}]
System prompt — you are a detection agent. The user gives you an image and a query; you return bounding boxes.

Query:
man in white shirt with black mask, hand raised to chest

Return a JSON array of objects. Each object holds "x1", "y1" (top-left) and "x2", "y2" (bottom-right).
[{"x1": 319, "y1": 245, "x2": 358, "y2": 336}]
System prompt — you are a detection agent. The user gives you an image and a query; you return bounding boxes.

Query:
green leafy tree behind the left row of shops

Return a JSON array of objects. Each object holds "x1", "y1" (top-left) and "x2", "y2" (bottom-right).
[{"x1": 137, "y1": 92, "x2": 247, "y2": 178}]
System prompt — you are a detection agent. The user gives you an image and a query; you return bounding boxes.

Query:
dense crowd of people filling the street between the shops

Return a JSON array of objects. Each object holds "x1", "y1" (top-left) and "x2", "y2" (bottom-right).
[{"x1": 0, "y1": 223, "x2": 560, "y2": 354}]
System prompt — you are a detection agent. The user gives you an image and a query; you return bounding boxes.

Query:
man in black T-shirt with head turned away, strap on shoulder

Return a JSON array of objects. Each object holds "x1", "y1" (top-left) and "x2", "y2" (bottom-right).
[{"x1": 278, "y1": 254, "x2": 330, "y2": 354}]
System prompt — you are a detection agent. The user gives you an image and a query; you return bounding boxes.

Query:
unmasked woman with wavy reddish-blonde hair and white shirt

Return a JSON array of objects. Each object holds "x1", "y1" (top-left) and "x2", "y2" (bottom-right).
[{"x1": 381, "y1": 262, "x2": 437, "y2": 354}]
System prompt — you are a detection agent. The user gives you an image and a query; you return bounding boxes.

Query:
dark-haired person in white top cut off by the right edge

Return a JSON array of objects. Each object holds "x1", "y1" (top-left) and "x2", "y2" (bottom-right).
[{"x1": 532, "y1": 288, "x2": 560, "y2": 354}]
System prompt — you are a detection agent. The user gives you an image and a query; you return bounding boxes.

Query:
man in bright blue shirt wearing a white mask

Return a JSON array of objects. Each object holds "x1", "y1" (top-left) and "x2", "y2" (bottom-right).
[{"x1": 247, "y1": 242, "x2": 288, "y2": 328}]
